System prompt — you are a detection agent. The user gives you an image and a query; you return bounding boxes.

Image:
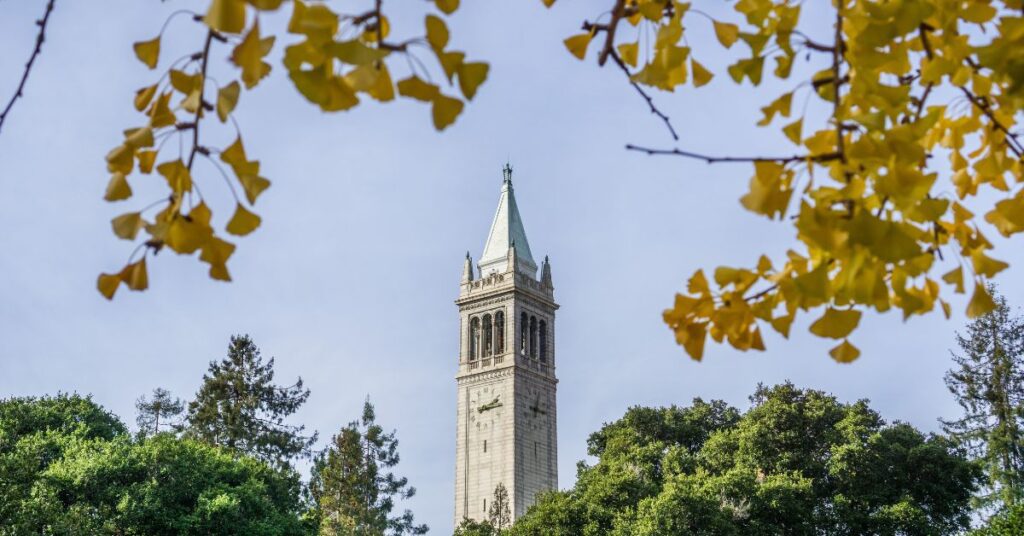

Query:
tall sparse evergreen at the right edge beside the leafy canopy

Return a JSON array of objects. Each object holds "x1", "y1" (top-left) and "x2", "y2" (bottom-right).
[{"x1": 943, "y1": 288, "x2": 1024, "y2": 508}]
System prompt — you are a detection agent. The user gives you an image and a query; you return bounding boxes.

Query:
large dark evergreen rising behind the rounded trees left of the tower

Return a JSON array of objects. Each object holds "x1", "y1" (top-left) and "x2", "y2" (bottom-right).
[{"x1": 186, "y1": 335, "x2": 316, "y2": 466}]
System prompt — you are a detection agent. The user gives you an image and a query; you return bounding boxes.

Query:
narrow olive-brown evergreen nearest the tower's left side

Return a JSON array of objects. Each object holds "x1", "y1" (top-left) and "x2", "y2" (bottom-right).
[{"x1": 309, "y1": 400, "x2": 427, "y2": 536}]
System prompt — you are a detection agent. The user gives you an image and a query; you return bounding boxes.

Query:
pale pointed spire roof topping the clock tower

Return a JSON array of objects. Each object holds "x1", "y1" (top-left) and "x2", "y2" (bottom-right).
[{"x1": 479, "y1": 164, "x2": 537, "y2": 276}]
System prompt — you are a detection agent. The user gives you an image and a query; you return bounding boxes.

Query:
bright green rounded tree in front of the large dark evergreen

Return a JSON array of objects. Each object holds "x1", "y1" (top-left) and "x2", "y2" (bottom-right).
[{"x1": 32, "y1": 434, "x2": 306, "y2": 536}]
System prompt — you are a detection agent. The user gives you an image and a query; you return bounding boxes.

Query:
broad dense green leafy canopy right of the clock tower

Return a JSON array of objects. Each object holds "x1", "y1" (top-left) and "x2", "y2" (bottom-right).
[{"x1": 512, "y1": 384, "x2": 980, "y2": 536}]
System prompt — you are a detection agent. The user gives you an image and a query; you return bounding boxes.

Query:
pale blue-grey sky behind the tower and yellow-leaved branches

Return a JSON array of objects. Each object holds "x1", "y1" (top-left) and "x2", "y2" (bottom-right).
[{"x1": 0, "y1": 0, "x2": 1024, "y2": 534}]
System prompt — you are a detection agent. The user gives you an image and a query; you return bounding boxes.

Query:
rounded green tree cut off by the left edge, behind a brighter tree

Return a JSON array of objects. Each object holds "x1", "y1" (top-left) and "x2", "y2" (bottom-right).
[{"x1": 0, "y1": 394, "x2": 128, "y2": 536}]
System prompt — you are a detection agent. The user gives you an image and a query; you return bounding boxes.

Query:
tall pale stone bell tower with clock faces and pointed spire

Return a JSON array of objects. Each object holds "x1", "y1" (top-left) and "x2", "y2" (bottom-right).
[{"x1": 455, "y1": 164, "x2": 558, "y2": 526}]
